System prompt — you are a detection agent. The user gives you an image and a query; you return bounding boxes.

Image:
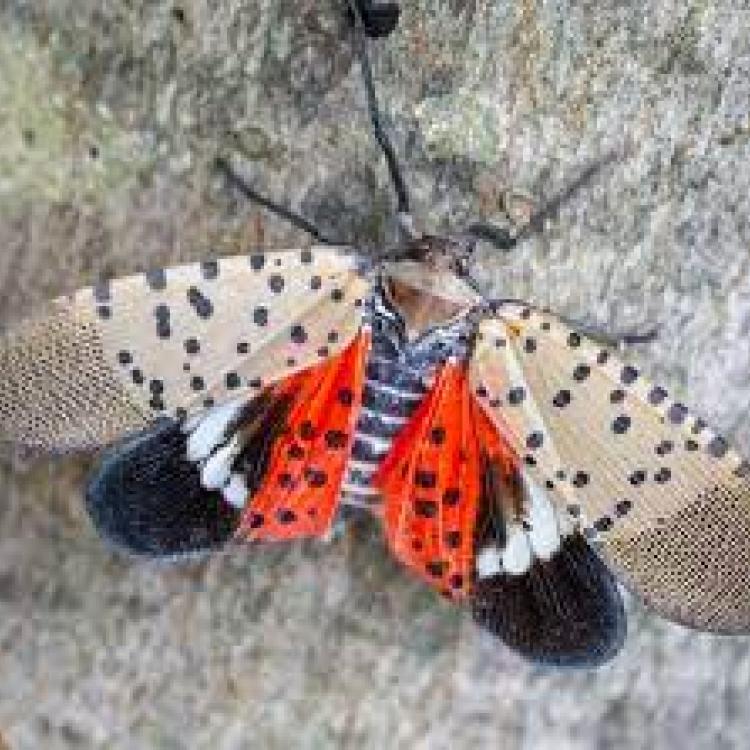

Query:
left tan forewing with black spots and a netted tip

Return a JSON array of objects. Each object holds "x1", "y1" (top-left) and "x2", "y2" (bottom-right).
[{"x1": 0, "y1": 247, "x2": 368, "y2": 451}]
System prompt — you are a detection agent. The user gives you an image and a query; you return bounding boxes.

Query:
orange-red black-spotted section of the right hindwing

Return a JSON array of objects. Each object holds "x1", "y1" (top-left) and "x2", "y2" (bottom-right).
[{"x1": 373, "y1": 362, "x2": 516, "y2": 598}]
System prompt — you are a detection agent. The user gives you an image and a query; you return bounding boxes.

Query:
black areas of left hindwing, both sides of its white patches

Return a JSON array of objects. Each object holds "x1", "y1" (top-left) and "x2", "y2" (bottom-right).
[{"x1": 86, "y1": 391, "x2": 291, "y2": 558}]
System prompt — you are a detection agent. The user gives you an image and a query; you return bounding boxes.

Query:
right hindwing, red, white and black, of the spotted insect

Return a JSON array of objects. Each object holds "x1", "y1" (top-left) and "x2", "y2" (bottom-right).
[{"x1": 374, "y1": 352, "x2": 626, "y2": 666}]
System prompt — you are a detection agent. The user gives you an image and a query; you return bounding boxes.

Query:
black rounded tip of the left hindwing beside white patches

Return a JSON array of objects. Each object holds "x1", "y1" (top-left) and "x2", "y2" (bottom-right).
[{"x1": 86, "y1": 419, "x2": 240, "y2": 558}]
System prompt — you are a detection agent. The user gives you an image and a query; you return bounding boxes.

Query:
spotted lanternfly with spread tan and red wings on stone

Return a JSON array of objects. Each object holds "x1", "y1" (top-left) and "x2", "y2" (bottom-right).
[{"x1": 0, "y1": 4, "x2": 750, "y2": 666}]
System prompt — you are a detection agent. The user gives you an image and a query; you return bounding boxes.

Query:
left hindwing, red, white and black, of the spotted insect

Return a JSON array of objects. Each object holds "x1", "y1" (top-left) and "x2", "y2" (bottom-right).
[{"x1": 86, "y1": 328, "x2": 370, "y2": 558}]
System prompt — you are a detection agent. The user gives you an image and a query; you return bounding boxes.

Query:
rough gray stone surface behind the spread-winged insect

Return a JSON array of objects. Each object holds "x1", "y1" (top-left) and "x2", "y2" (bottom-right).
[{"x1": 0, "y1": 0, "x2": 750, "y2": 750}]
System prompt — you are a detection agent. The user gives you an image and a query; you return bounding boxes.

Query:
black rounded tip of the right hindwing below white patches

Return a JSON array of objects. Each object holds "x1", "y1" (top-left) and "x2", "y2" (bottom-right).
[{"x1": 472, "y1": 534, "x2": 626, "y2": 667}]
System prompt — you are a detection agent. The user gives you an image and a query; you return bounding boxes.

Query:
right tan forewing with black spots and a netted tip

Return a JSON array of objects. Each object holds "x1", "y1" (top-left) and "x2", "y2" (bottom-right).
[{"x1": 471, "y1": 305, "x2": 750, "y2": 632}]
